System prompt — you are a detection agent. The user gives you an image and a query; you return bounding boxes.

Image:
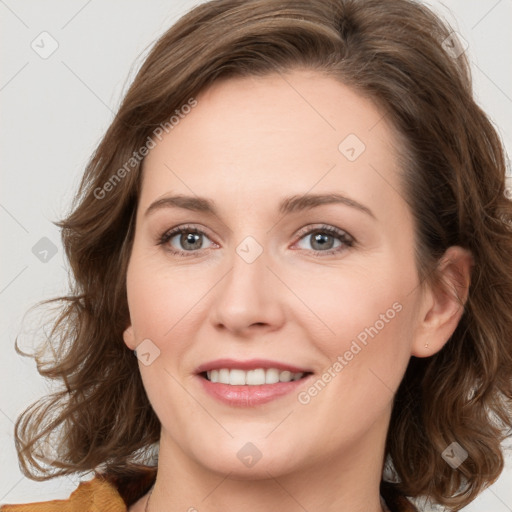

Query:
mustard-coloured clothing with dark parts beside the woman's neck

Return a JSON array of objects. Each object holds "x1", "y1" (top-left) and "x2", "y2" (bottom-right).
[{"x1": 0, "y1": 468, "x2": 418, "y2": 512}]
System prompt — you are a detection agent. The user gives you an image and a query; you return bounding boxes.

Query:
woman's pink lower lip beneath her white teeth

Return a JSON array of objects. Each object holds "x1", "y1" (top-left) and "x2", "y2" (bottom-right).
[{"x1": 197, "y1": 375, "x2": 311, "y2": 407}]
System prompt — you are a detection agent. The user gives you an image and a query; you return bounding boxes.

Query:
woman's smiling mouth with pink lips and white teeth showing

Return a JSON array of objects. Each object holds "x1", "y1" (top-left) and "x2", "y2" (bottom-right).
[{"x1": 196, "y1": 359, "x2": 313, "y2": 407}]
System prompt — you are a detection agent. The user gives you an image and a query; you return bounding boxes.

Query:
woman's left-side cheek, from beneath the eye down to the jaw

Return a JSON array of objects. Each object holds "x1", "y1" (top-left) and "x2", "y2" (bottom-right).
[{"x1": 127, "y1": 251, "x2": 204, "y2": 432}]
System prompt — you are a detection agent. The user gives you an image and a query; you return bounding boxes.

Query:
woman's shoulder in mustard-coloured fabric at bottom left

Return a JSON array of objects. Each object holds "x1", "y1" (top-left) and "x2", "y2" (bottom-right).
[{"x1": 0, "y1": 475, "x2": 127, "y2": 512}]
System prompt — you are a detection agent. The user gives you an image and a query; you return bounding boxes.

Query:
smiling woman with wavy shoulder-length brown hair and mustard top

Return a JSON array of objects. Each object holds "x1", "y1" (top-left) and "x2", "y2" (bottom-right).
[{"x1": 1, "y1": 0, "x2": 512, "y2": 512}]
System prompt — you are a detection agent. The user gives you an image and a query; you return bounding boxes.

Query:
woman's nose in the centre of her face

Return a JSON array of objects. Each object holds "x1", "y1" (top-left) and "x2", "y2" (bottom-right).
[{"x1": 210, "y1": 240, "x2": 285, "y2": 337}]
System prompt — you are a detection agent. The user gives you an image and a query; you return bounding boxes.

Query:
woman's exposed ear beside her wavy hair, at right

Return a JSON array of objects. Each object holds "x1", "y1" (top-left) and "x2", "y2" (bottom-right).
[{"x1": 411, "y1": 246, "x2": 474, "y2": 357}]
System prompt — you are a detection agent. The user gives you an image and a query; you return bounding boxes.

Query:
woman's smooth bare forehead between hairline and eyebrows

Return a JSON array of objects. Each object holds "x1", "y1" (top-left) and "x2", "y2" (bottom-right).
[{"x1": 141, "y1": 71, "x2": 408, "y2": 218}]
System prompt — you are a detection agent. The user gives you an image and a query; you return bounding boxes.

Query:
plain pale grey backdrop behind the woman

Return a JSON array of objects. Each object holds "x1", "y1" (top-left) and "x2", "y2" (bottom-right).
[{"x1": 0, "y1": 0, "x2": 512, "y2": 512}]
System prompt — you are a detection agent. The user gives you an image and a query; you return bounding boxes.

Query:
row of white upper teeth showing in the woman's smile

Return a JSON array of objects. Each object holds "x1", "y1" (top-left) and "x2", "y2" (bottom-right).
[{"x1": 206, "y1": 368, "x2": 304, "y2": 386}]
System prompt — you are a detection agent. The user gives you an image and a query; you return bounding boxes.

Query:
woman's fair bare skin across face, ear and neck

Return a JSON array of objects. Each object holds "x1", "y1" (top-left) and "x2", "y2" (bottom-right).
[{"x1": 124, "y1": 70, "x2": 471, "y2": 512}]
